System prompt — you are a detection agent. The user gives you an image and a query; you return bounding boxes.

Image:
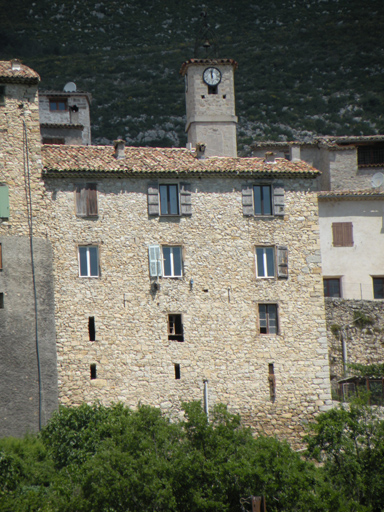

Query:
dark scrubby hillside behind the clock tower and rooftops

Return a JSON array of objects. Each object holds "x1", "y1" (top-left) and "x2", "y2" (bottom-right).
[{"x1": 0, "y1": 0, "x2": 384, "y2": 152}]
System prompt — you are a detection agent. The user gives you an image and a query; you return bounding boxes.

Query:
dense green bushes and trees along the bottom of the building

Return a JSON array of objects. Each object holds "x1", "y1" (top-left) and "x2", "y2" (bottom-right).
[{"x1": 0, "y1": 402, "x2": 384, "y2": 512}]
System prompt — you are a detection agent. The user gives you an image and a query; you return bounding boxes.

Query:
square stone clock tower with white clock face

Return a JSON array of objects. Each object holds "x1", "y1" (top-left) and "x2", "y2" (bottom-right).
[{"x1": 180, "y1": 58, "x2": 237, "y2": 157}]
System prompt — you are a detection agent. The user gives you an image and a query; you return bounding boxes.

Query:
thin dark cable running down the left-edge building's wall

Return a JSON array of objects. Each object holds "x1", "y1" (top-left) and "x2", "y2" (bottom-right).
[{"x1": 23, "y1": 120, "x2": 42, "y2": 431}]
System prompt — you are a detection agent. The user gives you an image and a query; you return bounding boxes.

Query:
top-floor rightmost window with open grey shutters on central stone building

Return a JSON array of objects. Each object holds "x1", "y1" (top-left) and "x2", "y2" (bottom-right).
[{"x1": 242, "y1": 183, "x2": 285, "y2": 217}]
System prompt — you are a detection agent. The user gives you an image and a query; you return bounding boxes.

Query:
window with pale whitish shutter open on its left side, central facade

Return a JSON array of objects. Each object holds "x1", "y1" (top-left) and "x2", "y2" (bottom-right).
[{"x1": 148, "y1": 245, "x2": 183, "y2": 277}]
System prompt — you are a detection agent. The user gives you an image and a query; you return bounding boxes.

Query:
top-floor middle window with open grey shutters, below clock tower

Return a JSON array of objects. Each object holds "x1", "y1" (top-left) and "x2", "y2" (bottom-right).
[{"x1": 148, "y1": 183, "x2": 192, "y2": 216}]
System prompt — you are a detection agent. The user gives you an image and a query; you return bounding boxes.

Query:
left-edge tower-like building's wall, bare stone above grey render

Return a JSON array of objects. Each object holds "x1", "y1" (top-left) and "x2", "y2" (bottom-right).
[{"x1": 0, "y1": 84, "x2": 57, "y2": 436}]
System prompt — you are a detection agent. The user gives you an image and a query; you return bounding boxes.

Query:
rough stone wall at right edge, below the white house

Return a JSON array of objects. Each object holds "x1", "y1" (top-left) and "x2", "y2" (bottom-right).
[{"x1": 325, "y1": 298, "x2": 384, "y2": 379}]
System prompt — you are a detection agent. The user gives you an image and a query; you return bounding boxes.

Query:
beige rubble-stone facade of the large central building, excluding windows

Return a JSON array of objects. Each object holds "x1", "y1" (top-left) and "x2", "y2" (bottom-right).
[{"x1": 46, "y1": 173, "x2": 331, "y2": 442}]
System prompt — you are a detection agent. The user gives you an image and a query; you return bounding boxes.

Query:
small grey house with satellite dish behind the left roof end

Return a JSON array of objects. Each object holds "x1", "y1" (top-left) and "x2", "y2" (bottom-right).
[{"x1": 39, "y1": 82, "x2": 91, "y2": 146}]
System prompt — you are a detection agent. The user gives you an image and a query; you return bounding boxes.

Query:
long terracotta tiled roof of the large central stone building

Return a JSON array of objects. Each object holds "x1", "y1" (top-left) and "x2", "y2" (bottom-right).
[{"x1": 41, "y1": 144, "x2": 320, "y2": 178}]
